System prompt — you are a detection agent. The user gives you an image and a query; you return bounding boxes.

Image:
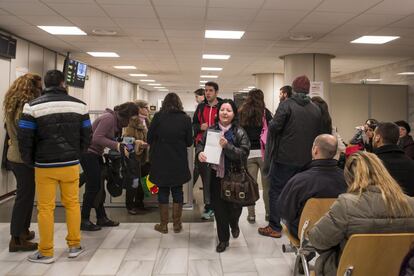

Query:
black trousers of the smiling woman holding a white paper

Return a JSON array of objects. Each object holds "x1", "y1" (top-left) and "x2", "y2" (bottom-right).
[{"x1": 210, "y1": 175, "x2": 242, "y2": 242}]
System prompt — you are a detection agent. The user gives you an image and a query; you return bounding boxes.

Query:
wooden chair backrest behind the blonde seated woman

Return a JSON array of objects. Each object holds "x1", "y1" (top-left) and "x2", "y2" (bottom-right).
[{"x1": 336, "y1": 233, "x2": 414, "y2": 276}]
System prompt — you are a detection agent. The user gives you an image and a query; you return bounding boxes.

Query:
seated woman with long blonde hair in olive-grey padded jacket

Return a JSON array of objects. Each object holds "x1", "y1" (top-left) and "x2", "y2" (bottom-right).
[{"x1": 308, "y1": 151, "x2": 414, "y2": 276}]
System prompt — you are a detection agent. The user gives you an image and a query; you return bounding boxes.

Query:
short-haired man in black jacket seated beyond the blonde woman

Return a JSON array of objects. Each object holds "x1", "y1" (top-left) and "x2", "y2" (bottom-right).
[{"x1": 372, "y1": 122, "x2": 414, "y2": 196}]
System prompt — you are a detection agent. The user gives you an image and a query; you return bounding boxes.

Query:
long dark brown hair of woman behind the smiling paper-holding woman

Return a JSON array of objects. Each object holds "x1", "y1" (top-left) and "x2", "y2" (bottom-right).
[{"x1": 239, "y1": 88, "x2": 266, "y2": 126}]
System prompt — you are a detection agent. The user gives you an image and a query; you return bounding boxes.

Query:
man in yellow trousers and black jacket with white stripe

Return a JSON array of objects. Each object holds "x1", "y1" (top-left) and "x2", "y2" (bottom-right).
[{"x1": 18, "y1": 70, "x2": 91, "y2": 263}]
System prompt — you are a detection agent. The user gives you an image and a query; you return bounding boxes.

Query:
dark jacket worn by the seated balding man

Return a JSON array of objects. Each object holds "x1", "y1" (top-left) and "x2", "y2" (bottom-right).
[{"x1": 277, "y1": 159, "x2": 347, "y2": 236}]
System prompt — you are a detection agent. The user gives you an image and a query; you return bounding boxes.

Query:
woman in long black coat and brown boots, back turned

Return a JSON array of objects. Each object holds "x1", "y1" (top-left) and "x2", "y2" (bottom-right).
[{"x1": 147, "y1": 93, "x2": 193, "y2": 234}]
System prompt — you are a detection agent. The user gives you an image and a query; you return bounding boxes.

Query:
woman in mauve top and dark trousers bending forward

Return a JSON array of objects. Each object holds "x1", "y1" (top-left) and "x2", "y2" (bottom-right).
[{"x1": 81, "y1": 102, "x2": 138, "y2": 231}]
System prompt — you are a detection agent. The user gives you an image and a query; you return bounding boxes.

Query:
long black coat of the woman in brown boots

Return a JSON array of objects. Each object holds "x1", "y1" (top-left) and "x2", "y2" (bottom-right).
[{"x1": 147, "y1": 111, "x2": 193, "y2": 187}]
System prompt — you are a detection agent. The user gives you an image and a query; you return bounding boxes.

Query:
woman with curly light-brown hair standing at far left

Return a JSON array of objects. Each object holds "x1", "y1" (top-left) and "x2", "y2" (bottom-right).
[{"x1": 3, "y1": 74, "x2": 42, "y2": 252}]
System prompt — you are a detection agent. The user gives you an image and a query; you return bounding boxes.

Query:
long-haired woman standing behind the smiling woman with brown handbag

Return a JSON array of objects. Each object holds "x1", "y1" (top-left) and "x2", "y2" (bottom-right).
[{"x1": 239, "y1": 88, "x2": 272, "y2": 223}]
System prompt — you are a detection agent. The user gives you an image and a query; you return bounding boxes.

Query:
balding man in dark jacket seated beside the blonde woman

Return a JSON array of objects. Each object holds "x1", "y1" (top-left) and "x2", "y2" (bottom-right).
[{"x1": 278, "y1": 134, "x2": 346, "y2": 238}]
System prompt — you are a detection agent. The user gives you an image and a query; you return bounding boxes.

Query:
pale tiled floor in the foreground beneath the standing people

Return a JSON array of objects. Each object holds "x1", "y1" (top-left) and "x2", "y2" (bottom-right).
[{"x1": 0, "y1": 202, "x2": 294, "y2": 276}]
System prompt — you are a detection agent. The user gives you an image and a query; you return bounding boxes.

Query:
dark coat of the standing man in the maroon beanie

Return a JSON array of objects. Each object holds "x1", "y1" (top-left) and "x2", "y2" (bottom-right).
[{"x1": 266, "y1": 93, "x2": 322, "y2": 167}]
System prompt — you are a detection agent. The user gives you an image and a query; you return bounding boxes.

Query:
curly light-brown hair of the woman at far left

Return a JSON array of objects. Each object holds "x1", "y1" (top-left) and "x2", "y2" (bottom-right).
[{"x1": 3, "y1": 73, "x2": 42, "y2": 121}]
